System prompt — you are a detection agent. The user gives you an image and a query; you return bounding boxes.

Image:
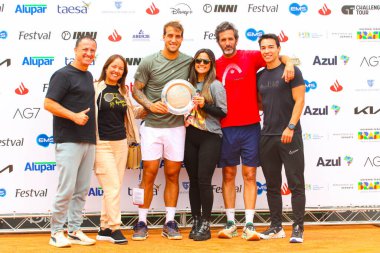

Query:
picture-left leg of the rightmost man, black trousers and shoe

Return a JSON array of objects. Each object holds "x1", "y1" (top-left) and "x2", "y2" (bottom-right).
[{"x1": 260, "y1": 136, "x2": 285, "y2": 239}]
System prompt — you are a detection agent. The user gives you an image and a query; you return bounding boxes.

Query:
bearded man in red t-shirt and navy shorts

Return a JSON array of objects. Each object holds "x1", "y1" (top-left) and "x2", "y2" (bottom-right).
[{"x1": 215, "y1": 22, "x2": 294, "y2": 241}]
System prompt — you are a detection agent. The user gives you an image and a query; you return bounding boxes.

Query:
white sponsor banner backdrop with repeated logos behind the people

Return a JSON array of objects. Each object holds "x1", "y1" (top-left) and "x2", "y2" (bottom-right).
[{"x1": 0, "y1": 0, "x2": 380, "y2": 214}]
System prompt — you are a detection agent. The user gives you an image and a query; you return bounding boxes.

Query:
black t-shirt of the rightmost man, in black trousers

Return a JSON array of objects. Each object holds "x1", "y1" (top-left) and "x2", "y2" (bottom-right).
[{"x1": 257, "y1": 64, "x2": 305, "y2": 135}]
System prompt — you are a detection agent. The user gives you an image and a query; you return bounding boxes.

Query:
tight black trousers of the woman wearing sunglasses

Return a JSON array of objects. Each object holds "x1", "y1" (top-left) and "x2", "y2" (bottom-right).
[{"x1": 184, "y1": 125, "x2": 222, "y2": 220}]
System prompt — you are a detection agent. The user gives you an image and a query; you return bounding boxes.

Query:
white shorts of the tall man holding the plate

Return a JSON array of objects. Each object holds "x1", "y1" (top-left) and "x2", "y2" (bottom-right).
[{"x1": 140, "y1": 124, "x2": 186, "y2": 162}]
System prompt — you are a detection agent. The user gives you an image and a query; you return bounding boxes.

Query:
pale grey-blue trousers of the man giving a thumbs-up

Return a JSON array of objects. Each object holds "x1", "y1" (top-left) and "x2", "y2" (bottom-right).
[{"x1": 51, "y1": 143, "x2": 95, "y2": 234}]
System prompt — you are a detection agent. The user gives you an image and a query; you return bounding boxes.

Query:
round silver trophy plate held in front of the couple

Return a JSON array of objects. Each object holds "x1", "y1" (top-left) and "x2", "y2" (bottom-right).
[{"x1": 161, "y1": 79, "x2": 196, "y2": 115}]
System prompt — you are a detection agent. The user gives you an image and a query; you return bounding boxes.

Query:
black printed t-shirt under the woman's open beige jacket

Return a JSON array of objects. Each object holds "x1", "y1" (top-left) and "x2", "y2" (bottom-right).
[{"x1": 97, "y1": 85, "x2": 127, "y2": 141}]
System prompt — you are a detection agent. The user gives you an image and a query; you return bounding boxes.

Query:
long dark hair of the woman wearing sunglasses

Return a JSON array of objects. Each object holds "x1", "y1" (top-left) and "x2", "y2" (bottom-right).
[{"x1": 189, "y1": 48, "x2": 216, "y2": 103}]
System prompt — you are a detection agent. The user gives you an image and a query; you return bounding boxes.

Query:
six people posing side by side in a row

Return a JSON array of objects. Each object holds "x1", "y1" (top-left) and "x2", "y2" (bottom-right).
[{"x1": 44, "y1": 21, "x2": 305, "y2": 247}]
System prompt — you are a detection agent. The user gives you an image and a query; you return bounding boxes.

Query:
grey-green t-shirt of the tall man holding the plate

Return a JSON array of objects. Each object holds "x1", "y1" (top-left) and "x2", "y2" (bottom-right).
[{"x1": 135, "y1": 52, "x2": 192, "y2": 128}]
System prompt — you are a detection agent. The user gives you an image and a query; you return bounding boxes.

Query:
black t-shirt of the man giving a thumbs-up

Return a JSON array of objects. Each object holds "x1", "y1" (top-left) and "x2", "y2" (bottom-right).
[{"x1": 46, "y1": 65, "x2": 96, "y2": 144}]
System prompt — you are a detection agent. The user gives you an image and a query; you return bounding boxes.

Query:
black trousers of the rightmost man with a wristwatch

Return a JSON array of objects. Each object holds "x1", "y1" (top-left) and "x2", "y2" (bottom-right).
[{"x1": 260, "y1": 134, "x2": 306, "y2": 227}]
